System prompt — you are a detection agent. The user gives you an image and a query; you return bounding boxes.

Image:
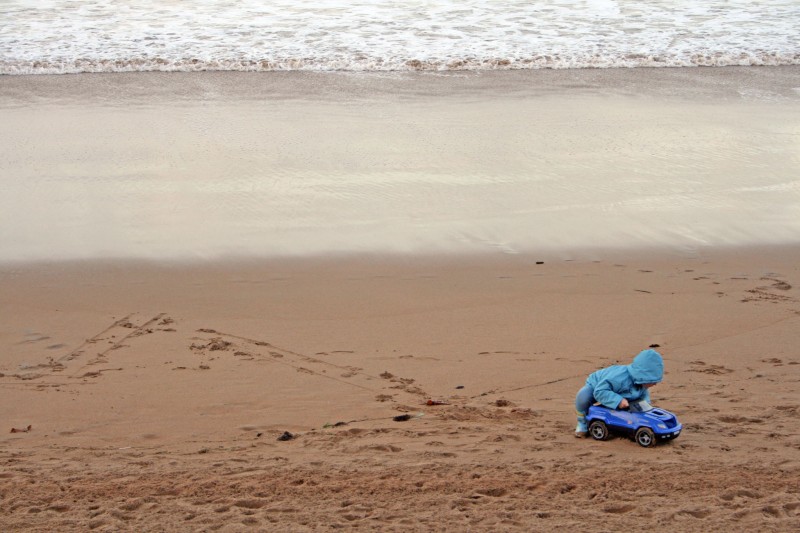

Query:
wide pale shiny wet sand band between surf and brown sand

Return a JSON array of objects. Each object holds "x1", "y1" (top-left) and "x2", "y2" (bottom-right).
[{"x1": 0, "y1": 67, "x2": 800, "y2": 261}]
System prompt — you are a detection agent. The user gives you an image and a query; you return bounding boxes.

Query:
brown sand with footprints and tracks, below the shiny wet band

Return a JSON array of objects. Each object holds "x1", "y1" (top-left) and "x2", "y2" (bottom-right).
[{"x1": 0, "y1": 246, "x2": 800, "y2": 531}]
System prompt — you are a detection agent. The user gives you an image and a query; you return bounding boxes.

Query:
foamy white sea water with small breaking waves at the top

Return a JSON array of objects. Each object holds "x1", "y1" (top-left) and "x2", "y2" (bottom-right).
[{"x1": 0, "y1": 0, "x2": 800, "y2": 74}]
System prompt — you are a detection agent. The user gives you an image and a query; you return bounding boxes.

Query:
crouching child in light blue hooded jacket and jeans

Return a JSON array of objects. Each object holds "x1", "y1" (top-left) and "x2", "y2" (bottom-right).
[{"x1": 575, "y1": 350, "x2": 664, "y2": 437}]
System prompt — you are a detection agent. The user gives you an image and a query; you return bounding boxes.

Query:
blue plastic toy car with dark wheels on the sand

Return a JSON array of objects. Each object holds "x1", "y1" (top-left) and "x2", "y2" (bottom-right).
[{"x1": 586, "y1": 400, "x2": 683, "y2": 448}]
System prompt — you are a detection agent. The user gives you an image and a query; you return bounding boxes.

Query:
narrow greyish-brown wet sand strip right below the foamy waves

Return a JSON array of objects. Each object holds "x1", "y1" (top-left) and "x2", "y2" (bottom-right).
[{"x1": 0, "y1": 65, "x2": 800, "y2": 105}]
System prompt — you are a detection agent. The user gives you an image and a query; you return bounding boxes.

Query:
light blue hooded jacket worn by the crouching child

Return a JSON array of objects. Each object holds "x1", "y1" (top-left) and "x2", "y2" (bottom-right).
[{"x1": 586, "y1": 350, "x2": 664, "y2": 409}]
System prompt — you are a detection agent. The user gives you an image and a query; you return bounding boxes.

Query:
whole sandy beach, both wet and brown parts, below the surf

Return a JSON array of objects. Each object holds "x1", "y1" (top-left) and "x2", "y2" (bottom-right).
[{"x1": 0, "y1": 69, "x2": 800, "y2": 532}]
